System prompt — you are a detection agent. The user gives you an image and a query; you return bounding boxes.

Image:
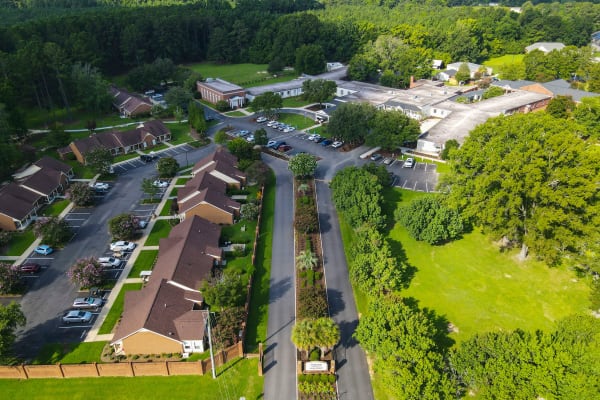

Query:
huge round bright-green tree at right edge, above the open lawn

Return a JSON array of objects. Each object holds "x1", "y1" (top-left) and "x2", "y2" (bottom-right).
[{"x1": 443, "y1": 113, "x2": 600, "y2": 263}]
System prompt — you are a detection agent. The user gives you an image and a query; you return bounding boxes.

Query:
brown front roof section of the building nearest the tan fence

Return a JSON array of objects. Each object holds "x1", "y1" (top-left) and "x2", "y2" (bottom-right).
[{"x1": 112, "y1": 279, "x2": 206, "y2": 343}]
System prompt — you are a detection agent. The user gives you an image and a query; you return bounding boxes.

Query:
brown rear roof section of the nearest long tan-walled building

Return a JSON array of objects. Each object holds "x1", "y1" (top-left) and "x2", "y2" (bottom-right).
[{"x1": 150, "y1": 216, "x2": 223, "y2": 290}]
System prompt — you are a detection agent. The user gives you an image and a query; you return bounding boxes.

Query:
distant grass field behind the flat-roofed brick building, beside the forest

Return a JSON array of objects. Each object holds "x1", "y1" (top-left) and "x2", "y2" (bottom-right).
[{"x1": 186, "y1": 62, "x2": 298, "y2": 87}]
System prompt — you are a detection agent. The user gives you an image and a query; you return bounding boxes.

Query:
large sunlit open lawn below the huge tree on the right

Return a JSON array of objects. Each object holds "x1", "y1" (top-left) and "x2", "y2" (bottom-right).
[{"x1": 389, "y1": 189, "x2": 589, "y2": 342}]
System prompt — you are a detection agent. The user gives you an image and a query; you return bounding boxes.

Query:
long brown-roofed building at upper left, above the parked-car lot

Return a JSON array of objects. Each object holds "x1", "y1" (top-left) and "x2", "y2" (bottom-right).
[{"x1": 69, "y1": 120, "x2": 171, "y2": 164}]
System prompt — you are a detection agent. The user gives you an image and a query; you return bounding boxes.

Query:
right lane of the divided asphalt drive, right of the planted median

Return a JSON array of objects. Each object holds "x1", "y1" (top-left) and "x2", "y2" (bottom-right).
[{"x1": 316, "y1": 181, "x2": 373, "y2": 400}]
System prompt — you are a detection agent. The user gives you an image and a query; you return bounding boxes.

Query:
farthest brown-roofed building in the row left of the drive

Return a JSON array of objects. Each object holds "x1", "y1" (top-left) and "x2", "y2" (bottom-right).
[{"x1": 192, "y1": 147, "x2": 246, "y2": 189}]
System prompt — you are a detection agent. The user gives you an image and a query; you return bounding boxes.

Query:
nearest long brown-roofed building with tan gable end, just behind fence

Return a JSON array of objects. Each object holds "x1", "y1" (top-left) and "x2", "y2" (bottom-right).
[{"x1": 111, "y1": 216, "x2": 223, "y2": 355}]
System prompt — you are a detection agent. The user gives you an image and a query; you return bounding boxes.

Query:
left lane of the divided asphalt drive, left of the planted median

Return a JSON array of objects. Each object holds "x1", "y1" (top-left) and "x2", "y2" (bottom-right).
[{"x1": 263, "y1": 156, "x2": 296, "y2": 400}]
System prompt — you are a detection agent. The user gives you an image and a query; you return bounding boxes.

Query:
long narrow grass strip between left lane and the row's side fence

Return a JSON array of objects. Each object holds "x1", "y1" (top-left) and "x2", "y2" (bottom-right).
[{"x1": 245, "y1": 171, "x2": 275, "y2": 353}]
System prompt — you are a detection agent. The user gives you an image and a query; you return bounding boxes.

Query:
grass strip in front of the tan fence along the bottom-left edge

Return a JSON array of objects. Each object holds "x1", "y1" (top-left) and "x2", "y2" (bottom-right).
[{"x1": 0, "y1": 358, "x2": 264, "y2": 400}]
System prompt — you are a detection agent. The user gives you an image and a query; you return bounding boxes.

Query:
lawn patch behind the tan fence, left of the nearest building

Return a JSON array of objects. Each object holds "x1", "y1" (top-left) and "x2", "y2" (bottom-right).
[{"x1": 32, "y1": 342, "x2": 108, "y2": 364}]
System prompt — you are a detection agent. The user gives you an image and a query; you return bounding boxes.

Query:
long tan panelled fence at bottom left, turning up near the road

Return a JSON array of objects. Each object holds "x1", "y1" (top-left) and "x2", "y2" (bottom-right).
[{"x1": 0, "y1": 342, "x2": 244, "y2": 379}]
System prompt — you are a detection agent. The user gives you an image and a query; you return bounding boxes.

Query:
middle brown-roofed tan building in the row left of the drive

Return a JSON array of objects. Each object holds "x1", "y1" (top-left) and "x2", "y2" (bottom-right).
[{"x1": 177, "y1": 171, "x2": 240, "y2": 225}]
